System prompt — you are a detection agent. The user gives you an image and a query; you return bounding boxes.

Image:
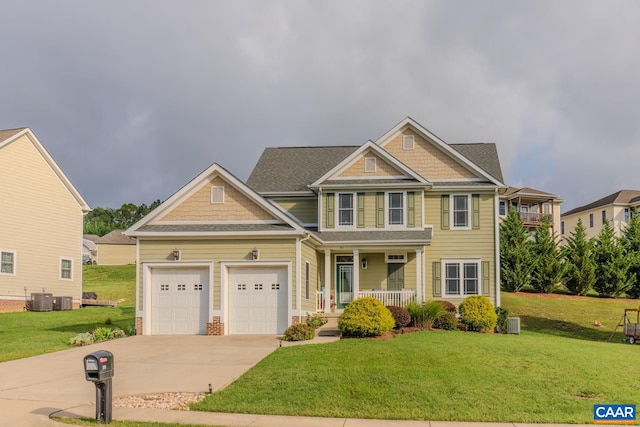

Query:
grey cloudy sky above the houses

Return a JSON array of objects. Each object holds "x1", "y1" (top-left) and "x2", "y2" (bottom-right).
[{"x1": 0, "y1": 0, "x2": 640, "y2": 211}]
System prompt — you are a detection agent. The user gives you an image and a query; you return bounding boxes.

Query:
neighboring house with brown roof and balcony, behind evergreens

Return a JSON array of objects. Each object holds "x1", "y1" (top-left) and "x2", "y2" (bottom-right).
[{"x1": 499, "y1": 187, "x2": 564, "y2": 236}]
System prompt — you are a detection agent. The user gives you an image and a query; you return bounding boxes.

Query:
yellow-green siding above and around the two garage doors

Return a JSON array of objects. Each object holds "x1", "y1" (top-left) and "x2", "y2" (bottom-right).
[{"x1": 138, "y1": 239, "x2": 296, "y2": 310}]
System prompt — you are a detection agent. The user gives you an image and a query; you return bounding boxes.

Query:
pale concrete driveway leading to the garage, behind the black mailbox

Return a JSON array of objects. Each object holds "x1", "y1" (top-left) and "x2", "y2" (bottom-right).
[{"x1": 0, "y1": 335, "x2": 280, "y2": 427}]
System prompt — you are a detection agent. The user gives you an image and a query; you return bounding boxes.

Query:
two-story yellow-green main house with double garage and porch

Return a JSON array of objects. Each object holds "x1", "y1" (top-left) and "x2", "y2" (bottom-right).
[{"x1": 126, "y1": 118, "x2": 507, "y2": 335}]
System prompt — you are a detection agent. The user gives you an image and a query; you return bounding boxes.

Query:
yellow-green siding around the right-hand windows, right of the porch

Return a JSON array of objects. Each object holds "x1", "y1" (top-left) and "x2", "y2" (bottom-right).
[{"x1": 425, "y1": 193, "x2": 496, "y2": 304}]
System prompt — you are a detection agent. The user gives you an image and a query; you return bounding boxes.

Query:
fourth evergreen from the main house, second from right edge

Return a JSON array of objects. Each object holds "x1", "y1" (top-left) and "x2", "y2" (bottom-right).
[{"x1": 593, "y1": 221, "x2": 635, "y2": 297}]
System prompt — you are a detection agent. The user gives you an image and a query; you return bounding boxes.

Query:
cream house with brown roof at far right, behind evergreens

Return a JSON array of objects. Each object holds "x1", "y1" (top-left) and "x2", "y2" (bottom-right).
[{"x1": 561, "y1": 190, "x2": 640, "y2": 238}]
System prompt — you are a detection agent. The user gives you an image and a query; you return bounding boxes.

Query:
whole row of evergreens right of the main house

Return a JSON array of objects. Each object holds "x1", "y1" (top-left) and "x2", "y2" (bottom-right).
[{"x1": 500, "y1": 209, "x2": 640, "y2": 298}]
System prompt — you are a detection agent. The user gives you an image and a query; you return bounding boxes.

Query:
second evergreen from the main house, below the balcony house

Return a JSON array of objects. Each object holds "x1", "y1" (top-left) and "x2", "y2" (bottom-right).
[{"x1": 531, "y1": 216, "x2": 565, "y2": 293}]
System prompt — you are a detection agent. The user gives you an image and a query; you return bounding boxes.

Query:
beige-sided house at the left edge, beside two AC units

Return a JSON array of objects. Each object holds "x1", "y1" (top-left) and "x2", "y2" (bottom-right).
[{"x1": 0, "y1": 128, "x2": 90, "y2": 311}]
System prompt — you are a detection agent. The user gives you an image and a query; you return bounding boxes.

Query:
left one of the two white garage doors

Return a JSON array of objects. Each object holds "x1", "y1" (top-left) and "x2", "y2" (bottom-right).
[{"x1": 151, "y1": 268, "x2": 210, "y2": 335}]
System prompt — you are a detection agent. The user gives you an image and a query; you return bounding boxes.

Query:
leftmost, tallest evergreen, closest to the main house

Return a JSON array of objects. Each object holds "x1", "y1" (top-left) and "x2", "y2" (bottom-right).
[{"x1": 500, "y1": 209, "x2": 534, "y2": 292}]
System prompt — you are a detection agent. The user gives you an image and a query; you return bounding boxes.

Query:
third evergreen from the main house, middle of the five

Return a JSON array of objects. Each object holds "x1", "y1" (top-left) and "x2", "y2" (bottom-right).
[{"x1": 562, "y1": 219, "x2": 596, "y2": 295}]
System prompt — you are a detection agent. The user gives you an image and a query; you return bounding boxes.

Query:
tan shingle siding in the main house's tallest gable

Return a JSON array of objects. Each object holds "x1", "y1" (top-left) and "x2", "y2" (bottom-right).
[{"x1": 384, "y1": 129, "x2": 475, "y2": 179}]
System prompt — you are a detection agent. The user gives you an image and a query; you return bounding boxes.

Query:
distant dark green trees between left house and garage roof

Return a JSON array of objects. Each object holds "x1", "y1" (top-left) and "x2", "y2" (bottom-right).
[{"x1": 83, "y1": 200, "x2": 162, "y2": 237}]
